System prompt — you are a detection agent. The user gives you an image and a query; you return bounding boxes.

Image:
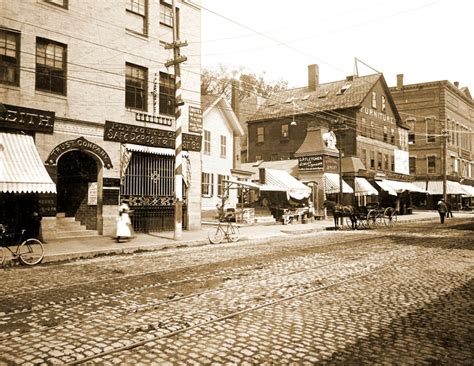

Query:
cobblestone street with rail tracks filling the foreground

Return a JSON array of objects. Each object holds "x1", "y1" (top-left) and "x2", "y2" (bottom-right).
[{"x1": 0, "y1": 219, "x2": 474, "y2": 365}]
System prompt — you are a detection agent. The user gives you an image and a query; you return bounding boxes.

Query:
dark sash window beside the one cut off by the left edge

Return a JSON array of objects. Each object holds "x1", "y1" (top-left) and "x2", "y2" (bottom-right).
[{"x1": 36, "y1": 37, "x2": 67, "y2": 95}]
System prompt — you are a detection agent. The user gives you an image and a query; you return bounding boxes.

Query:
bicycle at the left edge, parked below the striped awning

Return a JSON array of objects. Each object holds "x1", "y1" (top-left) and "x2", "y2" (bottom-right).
[{"x1": 0, "y1": 224, "x2": 44, "y2": 266}]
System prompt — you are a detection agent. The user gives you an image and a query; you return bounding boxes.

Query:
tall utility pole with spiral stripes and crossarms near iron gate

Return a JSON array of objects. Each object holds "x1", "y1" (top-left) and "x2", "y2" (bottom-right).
[{"x1": 165, "y1": 0, "x2": 188, "y2": 240}]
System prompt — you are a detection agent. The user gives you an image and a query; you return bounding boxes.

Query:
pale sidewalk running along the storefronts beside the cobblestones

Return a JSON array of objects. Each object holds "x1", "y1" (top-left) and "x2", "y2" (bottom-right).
[{"x1": 38, "y1": 211, "x2": 474, "y2": 263}]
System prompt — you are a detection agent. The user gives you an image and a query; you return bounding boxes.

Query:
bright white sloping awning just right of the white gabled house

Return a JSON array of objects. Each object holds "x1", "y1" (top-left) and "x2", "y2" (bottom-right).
[{"x1": 260, "y1": 168, "x2": 311, "y2": 200}]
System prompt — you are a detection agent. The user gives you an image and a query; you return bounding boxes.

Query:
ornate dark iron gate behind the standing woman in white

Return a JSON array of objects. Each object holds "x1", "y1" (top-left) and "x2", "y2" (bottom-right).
[{"x1": 121, "y1": 152, "x2": 187, "y2": 233}]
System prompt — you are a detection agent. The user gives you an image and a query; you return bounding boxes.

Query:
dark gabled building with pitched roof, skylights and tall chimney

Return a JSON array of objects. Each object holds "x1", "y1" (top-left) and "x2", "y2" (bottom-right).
[{"x1": 244, "y1": 65, "x2": 420, "y2": 213}]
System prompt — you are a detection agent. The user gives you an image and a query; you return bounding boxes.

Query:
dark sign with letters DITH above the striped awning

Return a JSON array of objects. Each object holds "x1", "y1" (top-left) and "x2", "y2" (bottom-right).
[{"x1": 0, "y1": 104, "x2": 54, "y2": 133}]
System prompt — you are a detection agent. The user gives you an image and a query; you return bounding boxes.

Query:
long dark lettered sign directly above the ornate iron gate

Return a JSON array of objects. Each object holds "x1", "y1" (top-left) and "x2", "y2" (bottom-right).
[{"x1": 104, "y1": 121, "x2": 202, "y2": 151}]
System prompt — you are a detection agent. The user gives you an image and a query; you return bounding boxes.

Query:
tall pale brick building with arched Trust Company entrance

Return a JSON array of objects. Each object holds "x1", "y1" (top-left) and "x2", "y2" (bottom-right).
[{"x1": 0, "y1": 0, "x2": 201, "y2": 238}]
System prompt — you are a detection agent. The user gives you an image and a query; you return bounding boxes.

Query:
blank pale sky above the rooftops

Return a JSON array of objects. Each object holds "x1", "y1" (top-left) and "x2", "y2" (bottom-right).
[{"x1": 201, "y1": 0, "x2": 474, "y2": 94}]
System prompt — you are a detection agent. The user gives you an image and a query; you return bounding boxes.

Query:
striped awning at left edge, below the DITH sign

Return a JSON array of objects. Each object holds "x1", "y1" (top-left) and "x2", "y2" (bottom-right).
[{"x1": 0, "y1": 132, "x2": 56, "y2": 193}]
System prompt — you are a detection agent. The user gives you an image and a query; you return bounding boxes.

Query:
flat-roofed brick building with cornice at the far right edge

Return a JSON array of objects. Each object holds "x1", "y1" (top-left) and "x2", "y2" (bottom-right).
[{"x1": 390, "y1": 74, "x2": 474, "y2": 208}]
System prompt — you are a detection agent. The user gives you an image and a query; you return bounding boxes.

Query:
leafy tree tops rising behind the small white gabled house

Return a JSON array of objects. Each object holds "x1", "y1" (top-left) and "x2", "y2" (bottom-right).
[{"x1": 201, "y1": 64, "x2": 288, "y2": 100}]
